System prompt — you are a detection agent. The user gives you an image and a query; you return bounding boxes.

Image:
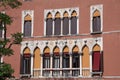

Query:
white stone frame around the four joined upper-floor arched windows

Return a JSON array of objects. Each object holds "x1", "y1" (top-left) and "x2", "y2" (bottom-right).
[{"x1": 44, "y1": 7, "x2": 79, "y2": 37}]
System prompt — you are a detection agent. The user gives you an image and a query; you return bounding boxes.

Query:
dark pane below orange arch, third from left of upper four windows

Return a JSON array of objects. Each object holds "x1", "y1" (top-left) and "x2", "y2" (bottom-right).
[{"x1": 63, "y1": 17, "x2": 69, "y2": 35}]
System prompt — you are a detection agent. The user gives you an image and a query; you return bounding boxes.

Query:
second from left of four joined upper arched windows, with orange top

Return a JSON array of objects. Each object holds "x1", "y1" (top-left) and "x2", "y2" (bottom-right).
[{"x1": 54, "y1": 12, "x2": 61, "y2": 35}]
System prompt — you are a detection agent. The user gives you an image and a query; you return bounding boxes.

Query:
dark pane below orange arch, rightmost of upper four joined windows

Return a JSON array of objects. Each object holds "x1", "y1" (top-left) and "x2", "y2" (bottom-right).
[{"x1": 71, "y1": 17, "x2": 77, "y2": 34}]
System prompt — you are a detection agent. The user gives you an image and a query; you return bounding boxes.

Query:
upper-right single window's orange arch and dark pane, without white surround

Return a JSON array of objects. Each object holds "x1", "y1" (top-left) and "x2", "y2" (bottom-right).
[{"x1": 92, "y1": 10, "x2": 101, "y2": 33}]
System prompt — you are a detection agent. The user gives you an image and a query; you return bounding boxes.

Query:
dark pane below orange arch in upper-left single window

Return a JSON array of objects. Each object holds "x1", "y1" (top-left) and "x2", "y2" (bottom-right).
[{"x1": 24, "y1": 21, "x2": 31, "y2": 37}]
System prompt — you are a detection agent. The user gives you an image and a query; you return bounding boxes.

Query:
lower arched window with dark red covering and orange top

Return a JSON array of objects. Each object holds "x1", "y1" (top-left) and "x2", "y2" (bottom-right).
[{"x1": 92, "y1": 44, "x2": 103, "y2": 76}]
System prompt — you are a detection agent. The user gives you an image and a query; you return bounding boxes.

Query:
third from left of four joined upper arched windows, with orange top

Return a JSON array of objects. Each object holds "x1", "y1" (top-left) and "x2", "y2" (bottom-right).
[{"x1": 63, "y1": 11, "x2": 69, "y2": 35}]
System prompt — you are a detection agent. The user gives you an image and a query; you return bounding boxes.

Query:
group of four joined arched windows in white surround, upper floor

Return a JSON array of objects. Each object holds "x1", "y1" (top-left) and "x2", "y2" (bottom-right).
[{"x1": 44, "y1": 8, "x2": 79, "y2": 36}]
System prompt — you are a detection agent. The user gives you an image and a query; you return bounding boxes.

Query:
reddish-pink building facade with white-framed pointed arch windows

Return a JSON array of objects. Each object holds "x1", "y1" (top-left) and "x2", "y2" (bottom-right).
[{"x1": 0, "y1": 0, "x2": 120, "y2": 80}]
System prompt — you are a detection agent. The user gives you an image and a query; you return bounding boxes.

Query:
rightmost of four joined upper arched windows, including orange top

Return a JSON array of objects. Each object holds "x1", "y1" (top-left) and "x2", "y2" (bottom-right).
[{"x1": 71, "y1": 11, "x2": 77, "y2": 34}]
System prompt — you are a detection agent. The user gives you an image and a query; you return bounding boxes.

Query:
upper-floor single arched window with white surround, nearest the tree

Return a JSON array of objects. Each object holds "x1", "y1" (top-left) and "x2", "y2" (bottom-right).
[{"x1": 22, "y1": 11, "x2": 33, "y2": 37}]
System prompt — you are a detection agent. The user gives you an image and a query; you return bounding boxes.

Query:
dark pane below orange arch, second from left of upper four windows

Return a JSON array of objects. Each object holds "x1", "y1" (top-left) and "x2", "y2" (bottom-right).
[{"x1": 54, "y1": 18, "x2": 61, "y2": 35}]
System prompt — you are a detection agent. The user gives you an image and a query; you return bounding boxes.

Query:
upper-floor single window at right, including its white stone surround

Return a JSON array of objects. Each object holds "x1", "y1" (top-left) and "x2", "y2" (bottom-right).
[{"x1": 91, "y1": 5, "x2": 103, "y2": 33}]
